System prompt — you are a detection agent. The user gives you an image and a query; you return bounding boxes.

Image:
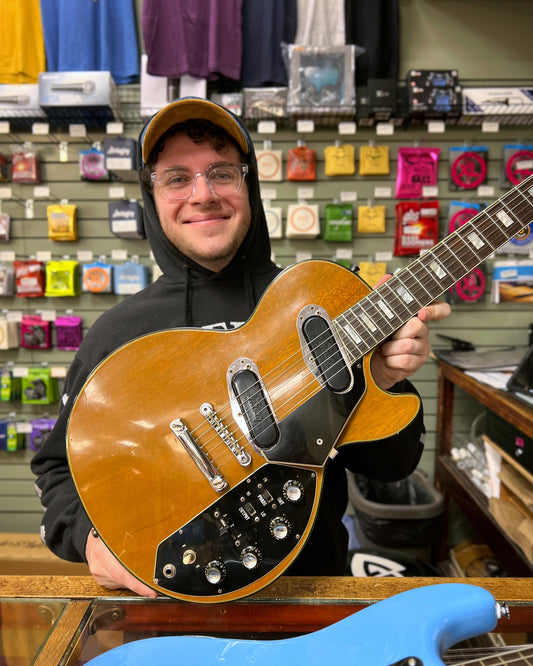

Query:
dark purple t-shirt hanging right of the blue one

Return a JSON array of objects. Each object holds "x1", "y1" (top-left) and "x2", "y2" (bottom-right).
[{"x1": 141, "y1": 0, "x2": 242, "y2": 81}]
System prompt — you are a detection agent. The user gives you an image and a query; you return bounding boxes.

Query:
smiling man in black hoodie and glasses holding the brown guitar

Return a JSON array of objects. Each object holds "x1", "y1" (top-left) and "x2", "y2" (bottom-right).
[{"x1": 32, "y1": 98, "x2": 449, "y2": 597}]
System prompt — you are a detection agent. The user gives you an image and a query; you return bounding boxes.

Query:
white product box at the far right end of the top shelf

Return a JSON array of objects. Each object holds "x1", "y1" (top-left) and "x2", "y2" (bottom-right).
[{"x1": 460, "y1": 86, "x2": 533, "y2": 125}]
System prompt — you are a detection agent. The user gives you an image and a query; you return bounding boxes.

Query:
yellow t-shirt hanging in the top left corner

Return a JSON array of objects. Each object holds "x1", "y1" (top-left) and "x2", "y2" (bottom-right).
[{"x1": 0, "y1": 0, "x2": 46, "y2": 83}]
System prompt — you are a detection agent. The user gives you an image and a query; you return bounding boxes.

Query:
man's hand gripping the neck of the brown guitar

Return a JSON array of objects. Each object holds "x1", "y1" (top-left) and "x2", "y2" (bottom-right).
[{"x1": 370, "y1": 276, "x2": 451, "y2": 389}]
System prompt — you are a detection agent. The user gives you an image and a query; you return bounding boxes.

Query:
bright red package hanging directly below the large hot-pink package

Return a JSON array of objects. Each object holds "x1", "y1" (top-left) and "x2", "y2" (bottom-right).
[{"x1": 394, "y1": 201, "x2": 439, "y2": 256}]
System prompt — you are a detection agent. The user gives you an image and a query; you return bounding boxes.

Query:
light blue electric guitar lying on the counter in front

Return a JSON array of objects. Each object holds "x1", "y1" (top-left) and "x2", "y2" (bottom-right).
[{"x1": 87, "y1": 583, "x2": 533, "y2": 666}]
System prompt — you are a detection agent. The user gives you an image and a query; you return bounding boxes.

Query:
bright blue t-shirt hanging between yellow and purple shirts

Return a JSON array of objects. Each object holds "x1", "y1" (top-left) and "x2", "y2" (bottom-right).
[{"x1": 41, "y1": 0, "x2": 139, "y2": 84}]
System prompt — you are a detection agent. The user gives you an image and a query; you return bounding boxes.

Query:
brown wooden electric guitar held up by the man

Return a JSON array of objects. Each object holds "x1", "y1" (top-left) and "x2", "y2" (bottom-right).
[{"x1": 67, "y1": 176, "x2": 533, "y2": 602}]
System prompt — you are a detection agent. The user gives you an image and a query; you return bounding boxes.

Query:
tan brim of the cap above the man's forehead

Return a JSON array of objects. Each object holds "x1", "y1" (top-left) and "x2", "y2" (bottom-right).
[{"x1": 141, "y1": 97, "x2": 250, "y2": 162}]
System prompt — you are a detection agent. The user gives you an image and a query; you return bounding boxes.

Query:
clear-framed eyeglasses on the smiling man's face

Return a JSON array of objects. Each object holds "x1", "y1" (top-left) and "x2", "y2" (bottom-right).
[{"x1": 150, "y1": 164, "x2": 248, "y2": 201}]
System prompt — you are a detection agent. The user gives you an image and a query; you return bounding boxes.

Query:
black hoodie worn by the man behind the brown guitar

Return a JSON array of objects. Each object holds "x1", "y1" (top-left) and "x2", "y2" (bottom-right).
[{"x1": 32, "y1": 102, "x2": 423, "y2": 575}]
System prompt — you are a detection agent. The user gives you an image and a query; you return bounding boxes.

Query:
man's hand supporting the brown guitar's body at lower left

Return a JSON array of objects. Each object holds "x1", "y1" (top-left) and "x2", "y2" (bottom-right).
[{"x1": 85, "y1": 532, "x2": 157, "y2": 599}]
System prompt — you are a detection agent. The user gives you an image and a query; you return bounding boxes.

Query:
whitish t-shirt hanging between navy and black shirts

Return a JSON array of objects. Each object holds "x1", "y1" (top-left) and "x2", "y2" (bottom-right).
[{"x1": 294, "y1": 0, "x2": 346, "y2": 46}]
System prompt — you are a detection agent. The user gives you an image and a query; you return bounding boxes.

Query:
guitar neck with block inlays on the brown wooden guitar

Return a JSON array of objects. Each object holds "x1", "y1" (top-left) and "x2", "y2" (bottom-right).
[{"x1": 335, "y1": 171, "x2": 533, "y2": 363}]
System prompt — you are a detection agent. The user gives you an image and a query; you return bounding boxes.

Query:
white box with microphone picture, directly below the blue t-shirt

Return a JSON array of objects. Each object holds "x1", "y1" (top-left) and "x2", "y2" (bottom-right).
[{"x1": 39, "y1": 71, "x2": 119, "y2": 127}]
